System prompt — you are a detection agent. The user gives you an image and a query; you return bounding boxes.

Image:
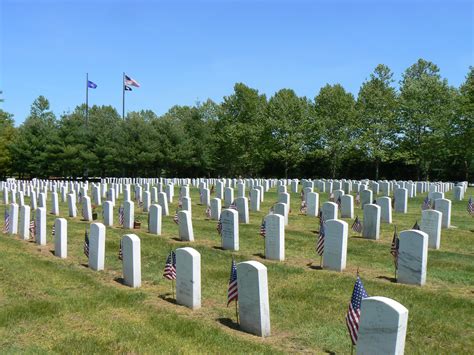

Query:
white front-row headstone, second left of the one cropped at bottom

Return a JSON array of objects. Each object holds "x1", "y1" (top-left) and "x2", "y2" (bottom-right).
[{"x1": 176, "y1": 247, "x2": 201, "y2": 309}]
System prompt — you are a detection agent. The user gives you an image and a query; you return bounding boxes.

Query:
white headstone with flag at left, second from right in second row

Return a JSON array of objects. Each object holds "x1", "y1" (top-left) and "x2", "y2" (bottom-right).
[{"x1": 323, "y1": 220, "x2": 352, "y2": 271}]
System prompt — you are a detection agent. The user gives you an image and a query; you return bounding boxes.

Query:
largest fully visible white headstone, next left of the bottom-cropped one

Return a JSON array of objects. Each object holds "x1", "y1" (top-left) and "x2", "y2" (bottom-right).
[{"x1": 237, "y1": 261, "x2": 270, "y2": 337}]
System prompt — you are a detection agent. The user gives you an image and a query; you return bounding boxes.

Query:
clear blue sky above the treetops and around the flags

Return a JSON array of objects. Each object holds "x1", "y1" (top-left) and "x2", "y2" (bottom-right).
[{"x1": 0, "y1": 0, "x2": 474, "y2": 124}]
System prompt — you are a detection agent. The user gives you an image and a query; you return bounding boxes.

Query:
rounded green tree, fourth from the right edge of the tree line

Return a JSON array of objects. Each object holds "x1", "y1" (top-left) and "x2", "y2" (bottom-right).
[{"x1": 313, "y1": 84, "x2": 357, "y2": 178}]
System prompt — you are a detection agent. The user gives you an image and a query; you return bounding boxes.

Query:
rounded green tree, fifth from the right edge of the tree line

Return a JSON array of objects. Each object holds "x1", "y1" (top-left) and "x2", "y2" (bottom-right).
[{"x1": 266, "y1": 89, "x2": 310, "y2": 178}]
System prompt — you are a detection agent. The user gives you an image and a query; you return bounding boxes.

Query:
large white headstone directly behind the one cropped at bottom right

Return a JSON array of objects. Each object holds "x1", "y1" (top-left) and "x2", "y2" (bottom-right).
[{"x1": 397, "y1": 229, "x2": 428, "y2": 286}]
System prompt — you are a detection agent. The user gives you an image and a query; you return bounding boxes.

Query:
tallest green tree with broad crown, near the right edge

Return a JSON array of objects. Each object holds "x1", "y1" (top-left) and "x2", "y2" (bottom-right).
[{"x1": 398, "y1": 59, "x2": 453, "y2": 180}]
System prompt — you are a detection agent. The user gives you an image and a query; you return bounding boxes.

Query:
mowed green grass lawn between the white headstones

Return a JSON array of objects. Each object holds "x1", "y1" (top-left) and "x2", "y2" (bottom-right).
[{"x1": 0, "y1": 187, "x2": 474, "y2": 354}]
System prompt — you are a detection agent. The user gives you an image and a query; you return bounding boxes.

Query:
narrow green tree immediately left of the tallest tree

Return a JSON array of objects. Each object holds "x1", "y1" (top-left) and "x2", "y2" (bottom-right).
[{"x1": 356, "y1": 64, "x2": 397, "y2": 180}]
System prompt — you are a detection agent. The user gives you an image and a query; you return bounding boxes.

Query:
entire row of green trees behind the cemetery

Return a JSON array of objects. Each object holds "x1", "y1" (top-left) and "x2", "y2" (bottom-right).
[{"x1": 0, "y1": 59, "x2": 474, "y2": 180}]
